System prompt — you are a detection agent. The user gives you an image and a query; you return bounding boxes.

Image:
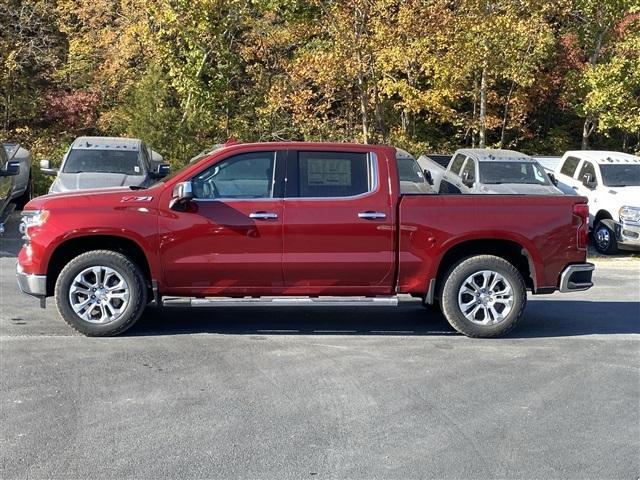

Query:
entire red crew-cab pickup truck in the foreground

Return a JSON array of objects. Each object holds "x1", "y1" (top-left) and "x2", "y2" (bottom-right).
[{"x1": 17, "y1": 143, "x2": 594, "y2": 337}]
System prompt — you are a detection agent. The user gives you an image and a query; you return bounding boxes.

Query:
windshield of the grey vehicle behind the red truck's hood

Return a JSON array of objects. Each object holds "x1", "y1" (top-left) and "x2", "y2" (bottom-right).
[{"x1": 62, "y1": 149, "x2": 143, "y2": 175}]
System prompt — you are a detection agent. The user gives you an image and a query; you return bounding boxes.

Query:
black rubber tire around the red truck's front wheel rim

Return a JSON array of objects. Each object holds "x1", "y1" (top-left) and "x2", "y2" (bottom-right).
[{"x1": 55, "y1": 250, "x2": 147, "y2": 337}]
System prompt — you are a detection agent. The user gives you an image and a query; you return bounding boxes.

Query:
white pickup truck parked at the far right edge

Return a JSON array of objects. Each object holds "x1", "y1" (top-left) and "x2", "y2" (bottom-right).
[{"x1": 555, "y1": 150, "x2": 640, "y2": 254}]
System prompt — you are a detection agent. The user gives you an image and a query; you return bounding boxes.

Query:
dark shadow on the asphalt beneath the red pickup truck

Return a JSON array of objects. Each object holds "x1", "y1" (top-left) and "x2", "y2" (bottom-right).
[{"x1": 125, "y1": 300, "x2": 640, "y2": 338}]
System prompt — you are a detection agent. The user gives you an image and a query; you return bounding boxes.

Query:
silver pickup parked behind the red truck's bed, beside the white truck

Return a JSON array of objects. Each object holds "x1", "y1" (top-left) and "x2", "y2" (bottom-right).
[{"x1": 418, "y1": 148, "x2": 562, "y2": 195}]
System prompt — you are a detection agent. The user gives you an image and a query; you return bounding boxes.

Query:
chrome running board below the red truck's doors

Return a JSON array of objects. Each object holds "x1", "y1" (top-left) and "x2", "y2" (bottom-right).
[{"x1": 162, "y1": 297, "x2": 398, "y2": 307}]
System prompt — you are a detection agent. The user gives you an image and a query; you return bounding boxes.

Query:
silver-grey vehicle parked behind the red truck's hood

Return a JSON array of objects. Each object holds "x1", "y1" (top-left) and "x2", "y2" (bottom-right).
[{"x1": 40, "y1": 137, "x2": 169, "y2": 193}]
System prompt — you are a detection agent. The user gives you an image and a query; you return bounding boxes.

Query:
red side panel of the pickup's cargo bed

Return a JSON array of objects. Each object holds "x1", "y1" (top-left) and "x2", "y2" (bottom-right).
[{"x1": 398, "y1": 195, "x2": 586, "y2": 293}]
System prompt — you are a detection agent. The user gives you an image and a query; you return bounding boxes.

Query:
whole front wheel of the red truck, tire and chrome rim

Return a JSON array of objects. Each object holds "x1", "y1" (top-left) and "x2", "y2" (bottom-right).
[{"x1": 55, "y1": 250, "x2": 147, "y2": 336}]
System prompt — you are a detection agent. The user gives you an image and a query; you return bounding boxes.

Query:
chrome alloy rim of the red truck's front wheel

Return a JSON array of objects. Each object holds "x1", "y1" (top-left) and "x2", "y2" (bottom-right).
[{"x1": 69, "y1": 266, "x2": 130, "y2": 324}]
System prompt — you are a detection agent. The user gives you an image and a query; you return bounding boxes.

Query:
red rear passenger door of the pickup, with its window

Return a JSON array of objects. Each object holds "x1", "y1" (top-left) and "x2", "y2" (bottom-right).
[{"x1": 283, "y1": 149, "x2": 395, "y2": 295}]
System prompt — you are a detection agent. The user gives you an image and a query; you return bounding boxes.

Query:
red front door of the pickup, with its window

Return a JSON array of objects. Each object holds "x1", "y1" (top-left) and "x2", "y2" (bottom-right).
[{"x1": 159, "y1": 151, "x2": 284, "y2": 295}]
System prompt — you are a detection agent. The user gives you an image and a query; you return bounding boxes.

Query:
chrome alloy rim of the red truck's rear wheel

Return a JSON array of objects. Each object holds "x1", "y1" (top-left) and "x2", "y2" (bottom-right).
[{"x1": 458, "y1": 270, "x2": 514, "y2": 325}]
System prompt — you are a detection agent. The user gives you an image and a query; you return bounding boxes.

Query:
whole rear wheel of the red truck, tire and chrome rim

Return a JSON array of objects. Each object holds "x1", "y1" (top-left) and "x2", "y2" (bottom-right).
[{"x1": 441, "y1": 255, "x2": 527, "y2": 337}]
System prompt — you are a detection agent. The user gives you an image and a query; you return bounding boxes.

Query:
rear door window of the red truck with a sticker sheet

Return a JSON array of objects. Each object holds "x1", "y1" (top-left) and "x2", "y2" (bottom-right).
[{"x1": 286, "y1": 151, "x2": 375, "y2": 198}]
